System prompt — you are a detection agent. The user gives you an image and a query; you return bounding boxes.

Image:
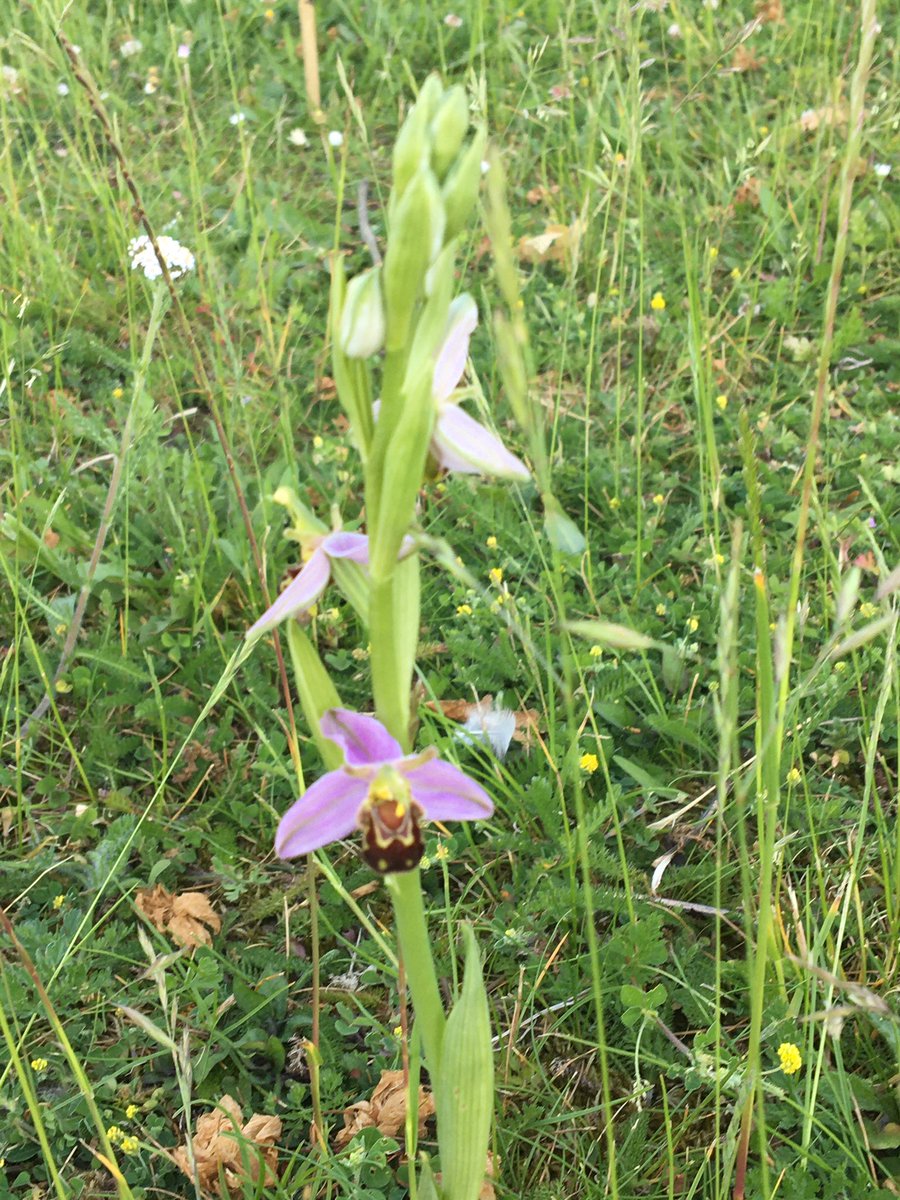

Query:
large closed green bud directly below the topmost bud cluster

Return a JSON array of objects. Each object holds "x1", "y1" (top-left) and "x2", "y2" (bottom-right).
[{"x1": 384, "y1": 167, "x2": 445, "y2": 350}]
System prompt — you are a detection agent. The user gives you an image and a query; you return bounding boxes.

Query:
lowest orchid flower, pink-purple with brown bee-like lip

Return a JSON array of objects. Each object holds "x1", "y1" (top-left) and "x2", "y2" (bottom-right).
[{"x1": 275, "y1": 708, "x2": 493, "y2": 874}]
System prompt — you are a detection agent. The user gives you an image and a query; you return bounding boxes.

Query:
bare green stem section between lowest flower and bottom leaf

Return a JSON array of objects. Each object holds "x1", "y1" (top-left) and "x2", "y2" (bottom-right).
[{"x1": 388, "y1": 868, "x2": 446, "y2": 1082}]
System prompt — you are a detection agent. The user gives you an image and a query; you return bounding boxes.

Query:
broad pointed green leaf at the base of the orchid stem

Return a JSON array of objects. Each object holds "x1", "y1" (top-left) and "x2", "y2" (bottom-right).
[{"x1": 434, "y1": 925, "x2": 493, "y2": 1200}]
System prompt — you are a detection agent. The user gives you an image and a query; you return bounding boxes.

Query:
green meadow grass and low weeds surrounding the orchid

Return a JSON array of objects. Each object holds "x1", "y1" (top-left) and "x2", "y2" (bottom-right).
[{"x1": 0, "y1": 0, "x2": 900, "y2": 1200}]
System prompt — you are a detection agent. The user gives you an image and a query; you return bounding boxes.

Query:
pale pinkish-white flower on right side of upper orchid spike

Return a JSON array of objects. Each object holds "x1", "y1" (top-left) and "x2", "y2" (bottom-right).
[{"x1": 431, "y1": 294, "x2": 532, "y2": 481}]
